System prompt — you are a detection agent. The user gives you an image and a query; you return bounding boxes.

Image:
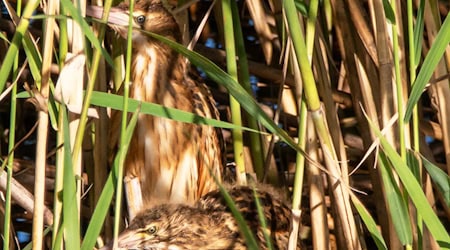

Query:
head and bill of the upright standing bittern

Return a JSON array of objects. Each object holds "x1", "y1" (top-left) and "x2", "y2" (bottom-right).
[{"x1": 86, "y1": 0, "x2": 181, "y2": 45}]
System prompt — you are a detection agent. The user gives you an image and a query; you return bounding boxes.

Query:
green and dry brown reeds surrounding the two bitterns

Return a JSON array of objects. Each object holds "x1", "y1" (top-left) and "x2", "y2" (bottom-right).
[{"x1": 0, "y1": 0, "x2": 450, "y2": 249}]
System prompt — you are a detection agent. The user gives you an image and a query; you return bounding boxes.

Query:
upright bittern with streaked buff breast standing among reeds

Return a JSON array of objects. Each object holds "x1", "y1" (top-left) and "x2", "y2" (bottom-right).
[{"x1": 87, "y1": 0, "x2": 223, "y2": 207}]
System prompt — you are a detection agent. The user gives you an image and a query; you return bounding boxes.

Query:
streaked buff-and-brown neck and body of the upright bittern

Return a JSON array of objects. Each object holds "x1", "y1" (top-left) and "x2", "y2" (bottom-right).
[{"x1": 125, "y1": 38, "x2": 222, "y2": 204}]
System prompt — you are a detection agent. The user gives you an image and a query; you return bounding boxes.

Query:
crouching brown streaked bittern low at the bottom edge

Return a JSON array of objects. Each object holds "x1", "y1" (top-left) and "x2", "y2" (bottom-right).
[{"x1": 104, "y1": 186, "x2": 300, "y2": 249}]
